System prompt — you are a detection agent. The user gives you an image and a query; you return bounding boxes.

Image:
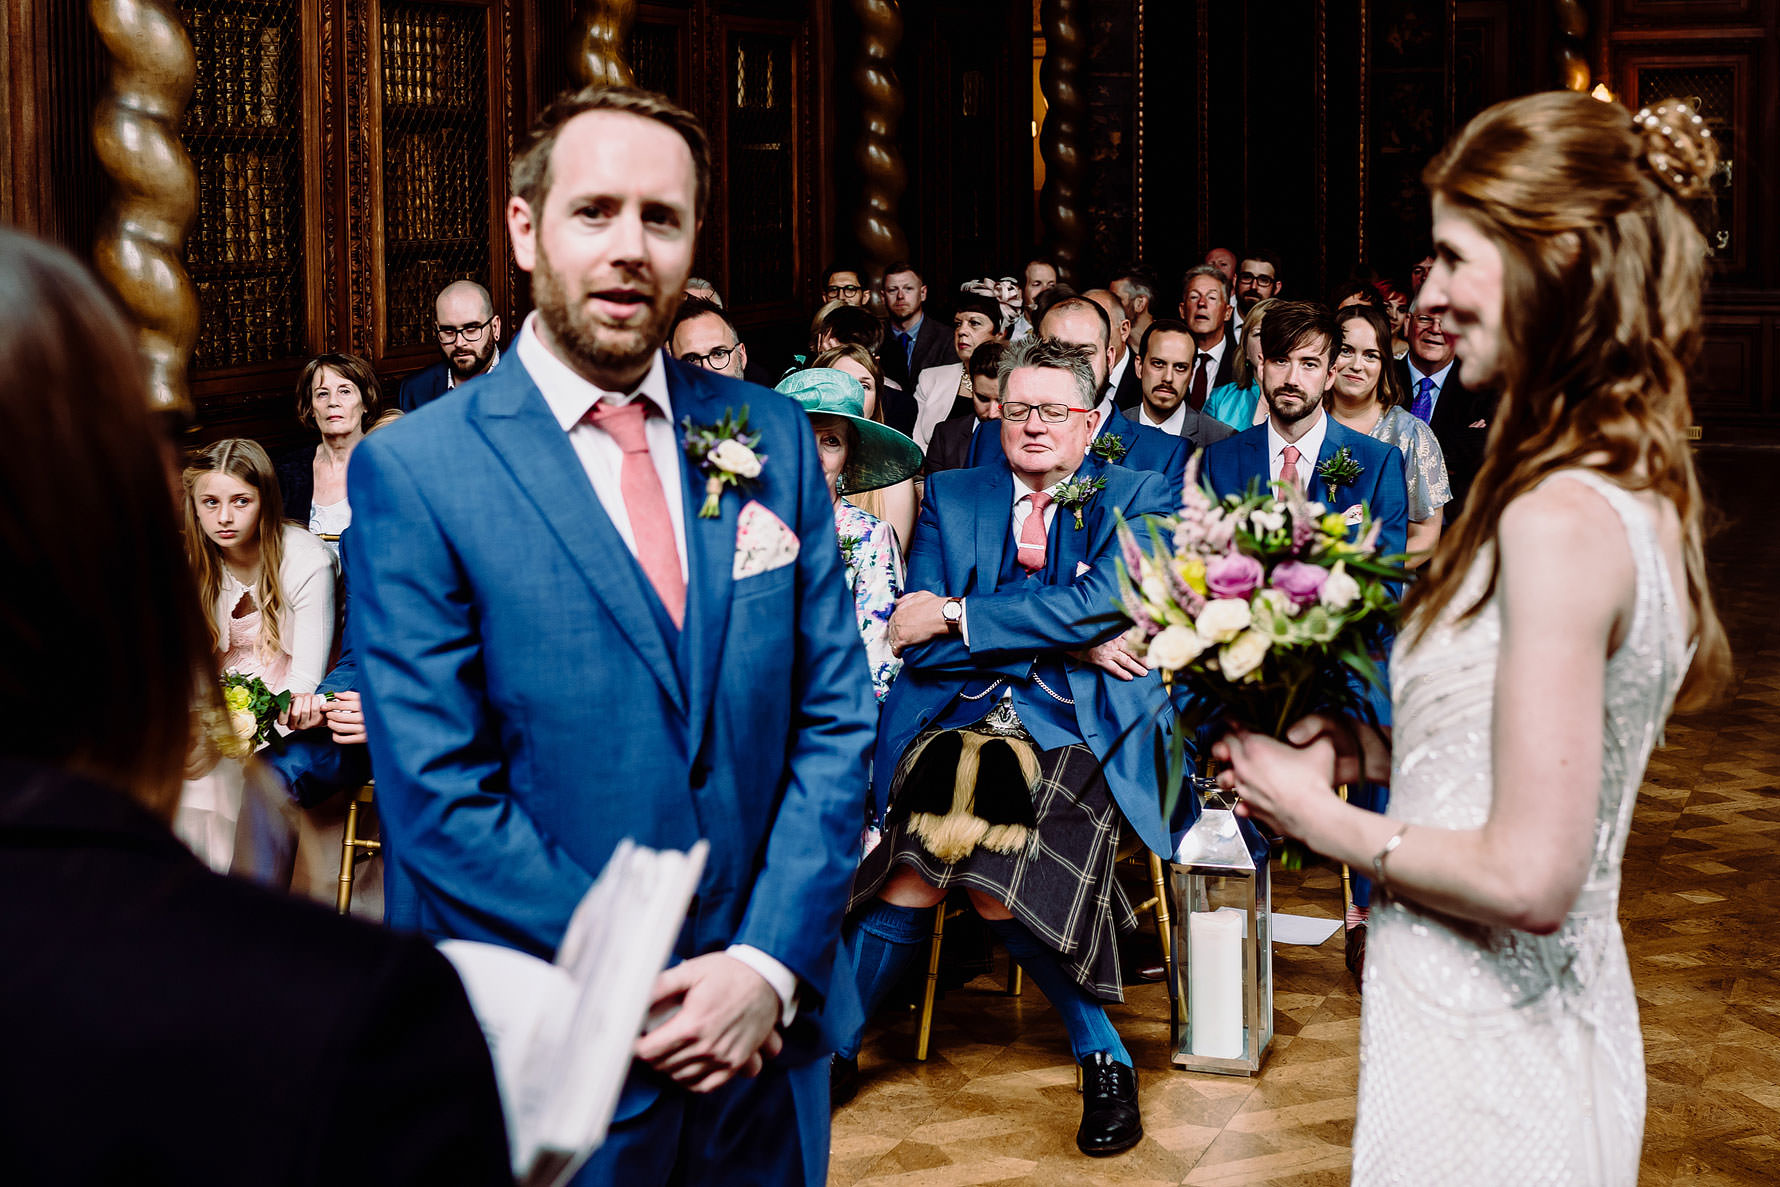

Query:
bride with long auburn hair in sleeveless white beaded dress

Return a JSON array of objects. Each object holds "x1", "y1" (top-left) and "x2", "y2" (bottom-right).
[{"x1": 1223, "y1": 91, "x2": 1730, "y2": 1187}]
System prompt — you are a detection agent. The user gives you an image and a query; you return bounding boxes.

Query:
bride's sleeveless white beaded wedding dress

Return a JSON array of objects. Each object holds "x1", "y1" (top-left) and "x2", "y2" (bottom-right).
[{"x1": 1353, "y1": 470, "x2": 1691, "y2": 1187}]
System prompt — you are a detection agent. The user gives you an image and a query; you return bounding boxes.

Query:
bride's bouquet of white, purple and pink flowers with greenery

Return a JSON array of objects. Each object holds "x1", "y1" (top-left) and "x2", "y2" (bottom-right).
[{"x1": 1120, "y1": 454, "x2": 1406, "y2": 839}]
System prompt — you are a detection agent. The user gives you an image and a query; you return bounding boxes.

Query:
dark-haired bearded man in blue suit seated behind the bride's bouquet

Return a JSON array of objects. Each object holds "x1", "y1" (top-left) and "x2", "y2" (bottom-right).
[{"x1": 1202, "y1": 301, "x2": 1410, "y2": 977}]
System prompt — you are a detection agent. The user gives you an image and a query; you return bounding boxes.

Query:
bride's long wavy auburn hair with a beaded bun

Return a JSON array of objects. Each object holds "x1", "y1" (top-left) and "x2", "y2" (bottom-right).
[{"x1": 1406, "y1": 91, "x2": 1730, "y2": 708}]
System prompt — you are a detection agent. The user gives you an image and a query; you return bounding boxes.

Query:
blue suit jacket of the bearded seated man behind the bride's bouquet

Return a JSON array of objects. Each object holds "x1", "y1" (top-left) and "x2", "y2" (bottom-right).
[{"x1": 1200, "y1": 409, "x2": 1410, "y2": 724}]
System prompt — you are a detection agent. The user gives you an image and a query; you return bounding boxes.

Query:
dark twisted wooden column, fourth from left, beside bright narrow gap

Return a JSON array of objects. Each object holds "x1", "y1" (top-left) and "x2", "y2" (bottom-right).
[{"x1": 1038, "y1": 0, "x2": 1088, "y2": 285}]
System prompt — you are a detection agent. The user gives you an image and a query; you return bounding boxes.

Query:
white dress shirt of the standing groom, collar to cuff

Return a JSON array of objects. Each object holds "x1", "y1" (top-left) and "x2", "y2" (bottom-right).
[{"x1": 514, "y1": 313, "x2": 797, "y2": 1025}]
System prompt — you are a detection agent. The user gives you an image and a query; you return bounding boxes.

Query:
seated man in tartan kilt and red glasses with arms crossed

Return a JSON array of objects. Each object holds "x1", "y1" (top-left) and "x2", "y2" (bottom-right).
[{"x1": 837, "y1": 338, "x2": 1175, "y2": 1155}]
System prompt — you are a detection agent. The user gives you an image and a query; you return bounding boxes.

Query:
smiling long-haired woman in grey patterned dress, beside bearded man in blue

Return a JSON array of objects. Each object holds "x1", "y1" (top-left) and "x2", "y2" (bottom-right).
[{"x1": 1328, "y1": 304, "x2": 1452, "y2": 568}]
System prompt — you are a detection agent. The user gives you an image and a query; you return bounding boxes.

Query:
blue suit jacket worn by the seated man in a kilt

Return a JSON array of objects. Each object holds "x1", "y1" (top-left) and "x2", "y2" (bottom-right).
[{"x1": 876, "y1": 459, "x2": 1175, "y2": 854}]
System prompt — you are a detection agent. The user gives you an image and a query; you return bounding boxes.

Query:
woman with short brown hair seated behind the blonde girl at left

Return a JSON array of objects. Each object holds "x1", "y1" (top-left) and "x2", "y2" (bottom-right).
[{"x1": 278, "y1": 354, "x2": 383, "y2": 555}]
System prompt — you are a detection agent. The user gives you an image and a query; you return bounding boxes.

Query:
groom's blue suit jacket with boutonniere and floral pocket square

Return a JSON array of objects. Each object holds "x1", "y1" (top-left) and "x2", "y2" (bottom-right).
[{"x1": 345, "y1": 350, "x2": 878, "y2": 1132}]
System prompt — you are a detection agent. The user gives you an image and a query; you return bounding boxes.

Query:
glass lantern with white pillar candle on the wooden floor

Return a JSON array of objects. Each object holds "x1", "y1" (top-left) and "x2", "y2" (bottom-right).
[{"x1": 1169, "y1": 785, "x2": 1273, "y2": 1075}]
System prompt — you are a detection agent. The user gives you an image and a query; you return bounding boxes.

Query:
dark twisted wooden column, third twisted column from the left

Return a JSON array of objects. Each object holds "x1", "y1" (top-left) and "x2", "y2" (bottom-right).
[{"x1": 853, "y1": 0, "x2": 908, "y2": 285}]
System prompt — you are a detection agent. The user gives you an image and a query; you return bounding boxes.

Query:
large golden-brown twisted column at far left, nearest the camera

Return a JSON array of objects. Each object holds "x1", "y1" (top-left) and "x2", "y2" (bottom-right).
[{"x1": 87, "y1": 0, "x2": 198, "y2": 415}]
